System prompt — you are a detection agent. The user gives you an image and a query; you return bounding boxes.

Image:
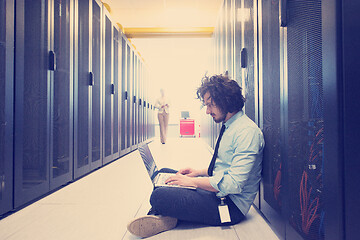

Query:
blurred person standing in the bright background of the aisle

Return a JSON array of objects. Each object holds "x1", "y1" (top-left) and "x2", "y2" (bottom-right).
[{"x1": 155, "y1": 89, "x2": 170, "y2": 144}]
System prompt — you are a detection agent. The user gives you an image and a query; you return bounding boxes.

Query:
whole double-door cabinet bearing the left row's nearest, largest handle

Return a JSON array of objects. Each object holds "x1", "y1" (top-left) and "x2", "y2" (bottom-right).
[{"x1": 14, "y1": 1, "x2": 73, "y2": 207}]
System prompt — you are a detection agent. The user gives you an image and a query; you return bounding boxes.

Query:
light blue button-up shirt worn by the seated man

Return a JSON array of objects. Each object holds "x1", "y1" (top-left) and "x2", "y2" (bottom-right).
[{"x1": 209, "y1": 111, "x2": 265, "y2": 215}]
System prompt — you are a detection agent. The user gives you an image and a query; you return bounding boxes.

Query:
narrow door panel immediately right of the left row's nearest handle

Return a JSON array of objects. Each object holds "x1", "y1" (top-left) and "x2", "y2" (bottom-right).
[{"x1": 49, "y1": 0, "x2": 74, "y2": 189}]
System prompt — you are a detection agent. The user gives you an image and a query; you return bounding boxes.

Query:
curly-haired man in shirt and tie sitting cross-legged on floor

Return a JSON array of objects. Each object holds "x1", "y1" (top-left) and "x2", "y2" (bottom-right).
[{"x1": 128, "y1": 75, "x2": 265, "y2": 237}]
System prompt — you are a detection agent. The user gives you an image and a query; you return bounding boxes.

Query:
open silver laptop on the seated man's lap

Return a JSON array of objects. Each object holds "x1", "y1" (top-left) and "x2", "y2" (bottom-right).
[{"x1": 138, "y1": 143, "x2": 196, "y2": 189}]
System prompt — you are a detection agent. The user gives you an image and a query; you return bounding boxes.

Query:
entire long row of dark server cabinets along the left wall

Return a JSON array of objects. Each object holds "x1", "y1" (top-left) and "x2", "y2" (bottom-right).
[{"x1": 0, "y1": 0, "x2": 153, "y2": 218}]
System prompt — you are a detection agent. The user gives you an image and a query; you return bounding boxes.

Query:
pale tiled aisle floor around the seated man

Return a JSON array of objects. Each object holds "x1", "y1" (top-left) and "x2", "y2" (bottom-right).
[{"x1": 0, "y1": 138, "x2": 277, "y2": 240}]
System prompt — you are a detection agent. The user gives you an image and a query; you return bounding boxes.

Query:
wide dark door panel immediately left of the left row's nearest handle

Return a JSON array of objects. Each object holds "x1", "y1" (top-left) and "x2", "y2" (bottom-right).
[{"x1": 14, "y1": 1, "x2": 50, "y2": 207}]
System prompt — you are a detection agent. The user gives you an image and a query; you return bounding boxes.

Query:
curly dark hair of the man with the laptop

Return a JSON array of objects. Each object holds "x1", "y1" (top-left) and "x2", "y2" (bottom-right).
[{"x1": 196, "y1": 75, "x2": 245, "y2": 114}]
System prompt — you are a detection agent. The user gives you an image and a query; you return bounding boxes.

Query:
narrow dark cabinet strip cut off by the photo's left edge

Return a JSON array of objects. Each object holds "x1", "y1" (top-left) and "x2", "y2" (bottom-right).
[{"x1": 0, "y1": 0, "x2": 14, "y2": 215}]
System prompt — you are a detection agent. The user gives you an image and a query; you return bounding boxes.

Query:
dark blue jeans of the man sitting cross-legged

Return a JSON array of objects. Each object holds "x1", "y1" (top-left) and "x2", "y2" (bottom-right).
[{"x1": 150, "y1": 169, "x2": 244, "y2": 226}]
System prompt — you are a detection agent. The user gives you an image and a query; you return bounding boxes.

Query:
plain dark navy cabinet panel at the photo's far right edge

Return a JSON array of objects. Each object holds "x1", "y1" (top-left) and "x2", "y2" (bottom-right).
[{"x1": 321, "y1": 0, "x2": 360, "y2": 239}]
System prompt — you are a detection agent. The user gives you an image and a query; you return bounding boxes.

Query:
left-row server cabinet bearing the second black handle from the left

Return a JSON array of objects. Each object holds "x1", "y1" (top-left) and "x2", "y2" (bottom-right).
[{"x1": 74, "y1": 0, "x2": 102, "y2": 178}]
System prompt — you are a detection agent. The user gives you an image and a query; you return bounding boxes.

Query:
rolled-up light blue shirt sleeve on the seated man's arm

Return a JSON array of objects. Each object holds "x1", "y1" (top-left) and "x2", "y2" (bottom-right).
[{"x1": 209, "y1": 128, "x2": 262, "y2": 197}]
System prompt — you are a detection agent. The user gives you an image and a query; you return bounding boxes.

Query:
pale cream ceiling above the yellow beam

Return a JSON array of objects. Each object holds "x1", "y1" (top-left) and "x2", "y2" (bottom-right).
[{"x1": 99, "y1": 0, "x2": 223, "y2": 28}]
